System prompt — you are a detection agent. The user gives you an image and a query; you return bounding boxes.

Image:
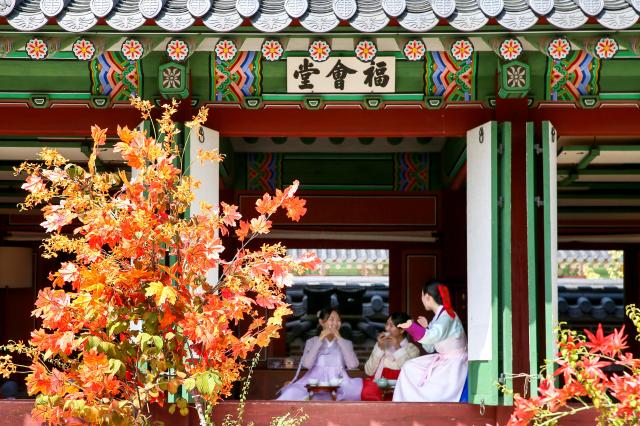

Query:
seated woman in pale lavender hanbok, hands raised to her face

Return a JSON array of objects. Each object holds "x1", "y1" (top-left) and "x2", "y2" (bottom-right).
[{"x1": 277, "y1": 309, "x2": 362, "y2": 401}]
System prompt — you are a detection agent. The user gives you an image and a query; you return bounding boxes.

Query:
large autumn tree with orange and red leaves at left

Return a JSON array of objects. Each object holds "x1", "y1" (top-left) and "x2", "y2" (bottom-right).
[{"x1": 0, "y1": 99, "x2": 318, "y2": 425}]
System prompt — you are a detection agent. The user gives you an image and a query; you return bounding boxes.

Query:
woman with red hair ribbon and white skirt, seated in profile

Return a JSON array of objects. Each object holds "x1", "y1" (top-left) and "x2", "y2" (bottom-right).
[{"x1": 393, "y1": 282, "x2": 468, "y2": 402}]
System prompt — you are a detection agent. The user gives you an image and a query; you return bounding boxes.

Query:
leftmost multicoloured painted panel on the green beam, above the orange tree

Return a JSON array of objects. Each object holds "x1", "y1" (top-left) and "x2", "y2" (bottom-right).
[{"x1": 91, "y1": 52, "x2": 142, "y2": 102}]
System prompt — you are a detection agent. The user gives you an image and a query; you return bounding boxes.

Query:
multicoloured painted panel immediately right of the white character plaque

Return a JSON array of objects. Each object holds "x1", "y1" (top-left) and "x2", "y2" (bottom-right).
[{"x1": 425, "y1": 52, "x2": 477, "y2": 101}]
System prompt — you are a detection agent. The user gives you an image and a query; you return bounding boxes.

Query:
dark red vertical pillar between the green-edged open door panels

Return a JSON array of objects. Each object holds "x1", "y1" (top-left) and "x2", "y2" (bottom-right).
[{"x1": 495, "y1": 98, "x2": 529, "y2": 392}]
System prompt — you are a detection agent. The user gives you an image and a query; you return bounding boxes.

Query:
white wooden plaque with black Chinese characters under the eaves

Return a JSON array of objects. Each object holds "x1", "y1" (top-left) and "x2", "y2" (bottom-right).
[{"x1": 287, "y1": 56, "x2": 396, "y2": 93}]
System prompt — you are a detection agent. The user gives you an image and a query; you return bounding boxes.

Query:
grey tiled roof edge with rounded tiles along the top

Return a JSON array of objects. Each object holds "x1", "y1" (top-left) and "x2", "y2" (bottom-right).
[{"x1": 0, "y1": 0, "x2": 640, "y2": 33}]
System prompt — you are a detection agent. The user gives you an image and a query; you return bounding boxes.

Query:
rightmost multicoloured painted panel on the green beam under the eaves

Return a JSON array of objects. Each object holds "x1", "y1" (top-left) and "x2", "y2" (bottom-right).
[{"x1": 545, "y1": 50, "x2": 600, "y2": 102}]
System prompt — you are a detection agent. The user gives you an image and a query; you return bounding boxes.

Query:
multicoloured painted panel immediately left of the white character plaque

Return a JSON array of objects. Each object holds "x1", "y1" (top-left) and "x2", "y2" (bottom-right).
[{"x1": 211, "y1": 52, "x2": 262, "y2": 103}]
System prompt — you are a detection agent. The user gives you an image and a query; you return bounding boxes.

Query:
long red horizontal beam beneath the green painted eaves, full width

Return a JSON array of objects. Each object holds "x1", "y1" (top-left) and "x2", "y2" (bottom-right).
[{"x1": 0, "y1": 103, "x2": 640, "y2": 137}]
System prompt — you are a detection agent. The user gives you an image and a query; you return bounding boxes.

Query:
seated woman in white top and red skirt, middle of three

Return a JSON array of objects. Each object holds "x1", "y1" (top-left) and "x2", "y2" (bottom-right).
[{"x1": 362, "y1": 312, "x2": 420, "y2": 401}]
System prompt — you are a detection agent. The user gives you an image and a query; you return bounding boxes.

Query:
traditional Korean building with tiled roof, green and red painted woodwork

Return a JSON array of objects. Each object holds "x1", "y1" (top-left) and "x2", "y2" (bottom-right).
[{"x1": 0, "y1": 0, "x2": 640, "y2": 422}]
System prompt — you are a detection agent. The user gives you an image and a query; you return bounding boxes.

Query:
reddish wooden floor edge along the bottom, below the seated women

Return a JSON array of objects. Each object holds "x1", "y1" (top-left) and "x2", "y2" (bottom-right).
[{"x1": 0, "y1": 400, "x2": 595, "y2": 426}]
